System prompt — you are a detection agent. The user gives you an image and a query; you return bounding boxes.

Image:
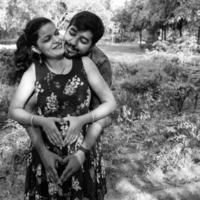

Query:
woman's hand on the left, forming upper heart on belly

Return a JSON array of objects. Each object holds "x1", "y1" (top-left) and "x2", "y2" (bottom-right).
[{"x1": 40, "y1": 117, "x2": 64, "y2": 146}]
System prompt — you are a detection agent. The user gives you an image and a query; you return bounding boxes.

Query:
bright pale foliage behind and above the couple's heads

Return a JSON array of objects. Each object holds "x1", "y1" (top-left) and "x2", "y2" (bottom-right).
[{"x1": 0, "y1": 0, "x2": 111, "y2": 38}]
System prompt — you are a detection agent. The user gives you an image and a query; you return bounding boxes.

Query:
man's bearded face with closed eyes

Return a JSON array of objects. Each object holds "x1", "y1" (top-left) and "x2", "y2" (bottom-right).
[{"x1": 64, "y1": 25, "x2": 93, "y2": 58}]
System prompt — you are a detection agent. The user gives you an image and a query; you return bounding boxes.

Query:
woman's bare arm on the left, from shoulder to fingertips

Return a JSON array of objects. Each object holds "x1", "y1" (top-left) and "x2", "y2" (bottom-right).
[{"x1": 9, "y1": 64, "x2": 63, "y2": 145}]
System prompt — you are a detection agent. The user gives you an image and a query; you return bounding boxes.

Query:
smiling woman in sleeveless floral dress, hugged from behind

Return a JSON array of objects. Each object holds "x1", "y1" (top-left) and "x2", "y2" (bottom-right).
[{"x1": 9, "y1": 18, "x2": 116, "y2": 200}]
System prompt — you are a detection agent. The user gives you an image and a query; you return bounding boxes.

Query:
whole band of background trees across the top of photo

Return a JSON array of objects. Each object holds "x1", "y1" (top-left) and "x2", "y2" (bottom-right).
[{"x1": 0, "y1": 0, "x2": 200, "y2": 43}]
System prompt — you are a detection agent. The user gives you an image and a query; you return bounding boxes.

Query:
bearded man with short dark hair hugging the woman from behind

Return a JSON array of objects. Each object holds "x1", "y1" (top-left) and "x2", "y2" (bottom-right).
[{"x1": 24, "y1": 11, "x2": 112, "y2": 186}]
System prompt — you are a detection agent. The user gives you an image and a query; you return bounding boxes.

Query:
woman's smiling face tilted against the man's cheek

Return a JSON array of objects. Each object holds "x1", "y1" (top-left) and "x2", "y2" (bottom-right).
[{"x1": 37, "y1": 23, "x2": 64, "y2": 58}]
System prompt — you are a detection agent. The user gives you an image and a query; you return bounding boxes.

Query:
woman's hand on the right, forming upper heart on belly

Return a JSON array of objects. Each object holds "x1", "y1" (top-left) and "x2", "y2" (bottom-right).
[{"x1": 63, "y1": 116, "x2": 84, "y2": 145}]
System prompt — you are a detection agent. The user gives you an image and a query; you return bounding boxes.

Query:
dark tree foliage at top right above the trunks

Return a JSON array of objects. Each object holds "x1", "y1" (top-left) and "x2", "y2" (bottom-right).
[{"x1": 112, "y1": 0, "x2": 200, "y2": 43}]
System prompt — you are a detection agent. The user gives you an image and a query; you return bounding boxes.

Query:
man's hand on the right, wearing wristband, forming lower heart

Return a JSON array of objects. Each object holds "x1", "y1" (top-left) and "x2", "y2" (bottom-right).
[{"x1": 60, "y1": 150, "x2": 85, "y2": 183}]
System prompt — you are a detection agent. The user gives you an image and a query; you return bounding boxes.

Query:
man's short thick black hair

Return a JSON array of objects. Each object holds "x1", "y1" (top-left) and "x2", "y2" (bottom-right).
[{"x1": 69, "y1": 11, "x2": 105, "y2": 44}]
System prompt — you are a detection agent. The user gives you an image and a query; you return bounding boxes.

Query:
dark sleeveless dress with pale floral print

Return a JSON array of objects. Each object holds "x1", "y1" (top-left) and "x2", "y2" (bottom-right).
[{"x1": 24, "y1": 58, "x2": 106, "y2": 200}]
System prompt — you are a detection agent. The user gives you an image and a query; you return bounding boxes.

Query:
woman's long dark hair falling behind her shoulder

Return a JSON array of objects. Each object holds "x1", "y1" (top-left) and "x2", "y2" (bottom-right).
[{"x1": 14, "y1": 17, "x2": 52, "y2": 81}]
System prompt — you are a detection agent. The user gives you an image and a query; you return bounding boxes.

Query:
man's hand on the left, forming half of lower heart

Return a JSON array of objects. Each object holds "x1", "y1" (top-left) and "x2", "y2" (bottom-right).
[{"x1": 40, "y1": 148, "x2": 63, "y2": 184}]
